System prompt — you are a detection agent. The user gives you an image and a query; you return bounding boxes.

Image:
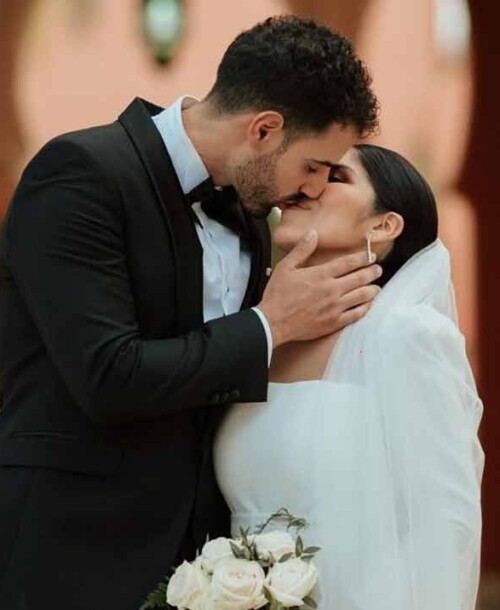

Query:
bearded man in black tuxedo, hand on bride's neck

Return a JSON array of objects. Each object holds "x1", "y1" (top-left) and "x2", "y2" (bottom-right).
[{"x1": 0, "y1": 17, "x2": 379, "y2": 610}]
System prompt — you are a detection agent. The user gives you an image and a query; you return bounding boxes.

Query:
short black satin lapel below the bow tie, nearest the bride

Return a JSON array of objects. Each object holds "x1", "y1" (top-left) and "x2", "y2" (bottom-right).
[{"x1": 241, "y1": 210, "x2": 271, "y2": 309}]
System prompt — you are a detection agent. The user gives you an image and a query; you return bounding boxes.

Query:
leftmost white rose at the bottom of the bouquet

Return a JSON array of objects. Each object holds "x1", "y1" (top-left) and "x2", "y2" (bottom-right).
[{"x1": 167, "y1": 561, "x2": 210, "y2": 610}]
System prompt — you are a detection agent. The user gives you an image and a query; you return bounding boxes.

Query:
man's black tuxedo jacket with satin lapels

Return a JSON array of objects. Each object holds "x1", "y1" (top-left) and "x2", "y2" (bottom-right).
[{"x1": 0, "y1": 99, "x2": 270, "y2": 610}]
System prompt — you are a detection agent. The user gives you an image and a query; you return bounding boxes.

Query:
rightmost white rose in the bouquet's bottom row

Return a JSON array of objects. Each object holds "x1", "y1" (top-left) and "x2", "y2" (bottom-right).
[{"x1": 266, "y1": 558, "x2": 318, "y2": 608}]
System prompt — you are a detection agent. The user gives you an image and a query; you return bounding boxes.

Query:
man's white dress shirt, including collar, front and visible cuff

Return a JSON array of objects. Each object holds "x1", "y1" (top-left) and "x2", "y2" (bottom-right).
[{"x1": 153, "y1": 96, "x2": 273, "y2": 362}]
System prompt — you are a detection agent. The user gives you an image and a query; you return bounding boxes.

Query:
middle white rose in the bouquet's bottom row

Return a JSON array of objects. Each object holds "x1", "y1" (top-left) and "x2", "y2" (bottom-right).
[{"x1": 208, "y1": 557, "x2": 267, "y2": 610}]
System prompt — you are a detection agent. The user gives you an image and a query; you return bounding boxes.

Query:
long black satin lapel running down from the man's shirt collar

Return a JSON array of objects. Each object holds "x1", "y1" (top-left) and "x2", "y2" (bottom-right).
[{"x1": 118, "y1": 98, "x2": 203, "y2": 335}]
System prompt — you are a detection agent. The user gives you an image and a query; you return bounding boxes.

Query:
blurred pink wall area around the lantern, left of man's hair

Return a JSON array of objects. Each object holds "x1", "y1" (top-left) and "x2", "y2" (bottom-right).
[{"x1": 18, "y1": 0, "x2": 286, "y2": 163}]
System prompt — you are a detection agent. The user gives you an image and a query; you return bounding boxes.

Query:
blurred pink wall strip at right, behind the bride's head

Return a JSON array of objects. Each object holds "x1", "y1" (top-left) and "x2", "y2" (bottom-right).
[{"x1": 358, "y1": 0, "x2": 479, "y2": 364}]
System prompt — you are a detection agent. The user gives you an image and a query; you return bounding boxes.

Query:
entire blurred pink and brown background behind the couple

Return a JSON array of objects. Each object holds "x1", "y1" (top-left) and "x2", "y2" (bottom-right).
[{"x1": 0, "y1": 0, "x2": 500, "y2": 610}]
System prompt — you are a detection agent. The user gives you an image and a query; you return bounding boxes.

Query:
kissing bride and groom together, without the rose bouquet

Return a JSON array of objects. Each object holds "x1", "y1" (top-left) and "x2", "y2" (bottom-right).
[{"x1": 0, "y1": 16, "x2": 483, "y2": 610}]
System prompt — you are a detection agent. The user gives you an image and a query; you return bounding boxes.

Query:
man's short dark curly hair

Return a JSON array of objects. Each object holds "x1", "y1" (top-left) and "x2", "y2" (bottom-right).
[{"x1": 208, "y1": 15, "x2": 378, "y2": 136}]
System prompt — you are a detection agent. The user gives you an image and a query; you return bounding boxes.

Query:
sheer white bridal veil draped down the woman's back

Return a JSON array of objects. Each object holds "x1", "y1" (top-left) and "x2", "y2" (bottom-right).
[{"x1": 311, "y1": 241, "x2": 483, "y2": 610}]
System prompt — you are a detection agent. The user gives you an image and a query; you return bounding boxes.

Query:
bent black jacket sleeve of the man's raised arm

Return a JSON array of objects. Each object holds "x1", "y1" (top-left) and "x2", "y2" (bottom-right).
[{"x1": 4, "y1": 137, "x2": 268, "y2": 424}]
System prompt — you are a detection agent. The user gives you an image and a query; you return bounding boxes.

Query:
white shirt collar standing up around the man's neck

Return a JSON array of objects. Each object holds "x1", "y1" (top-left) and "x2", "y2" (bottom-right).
[{"x1": 153, "y1": 95, "x2": 209, "y2": 194}]
